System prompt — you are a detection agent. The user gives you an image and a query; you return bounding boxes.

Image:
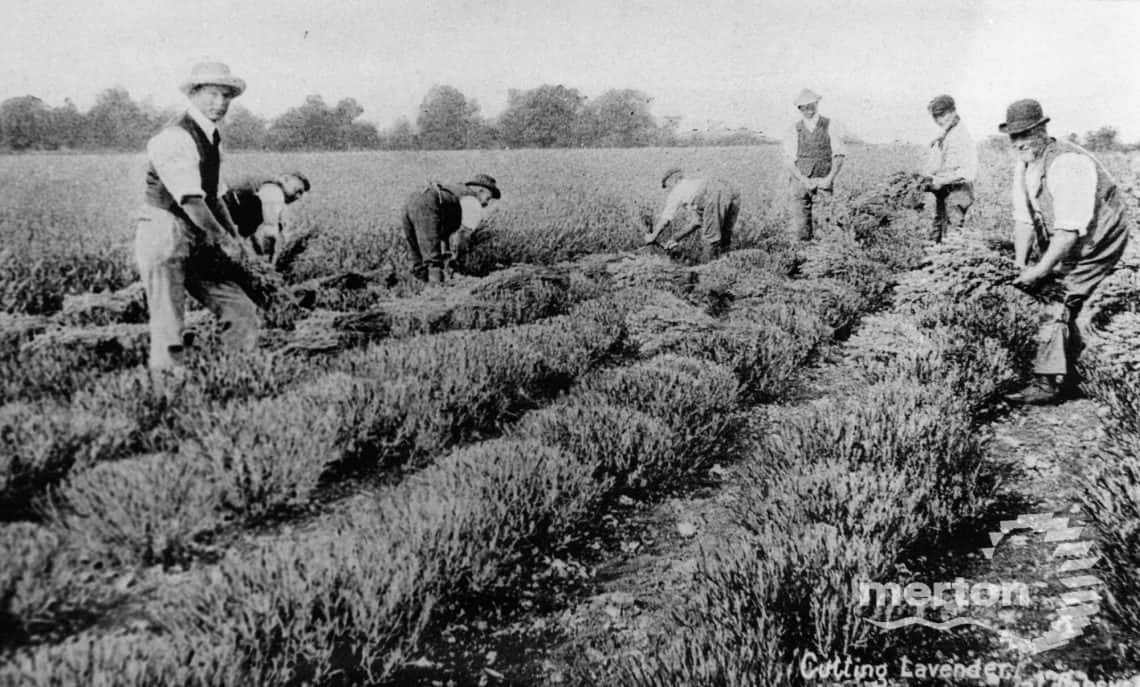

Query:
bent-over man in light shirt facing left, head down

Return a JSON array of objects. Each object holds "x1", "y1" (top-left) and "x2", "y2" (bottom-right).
[{"x1": 643, "y1": 167, "x2": 740, "y2": 262}]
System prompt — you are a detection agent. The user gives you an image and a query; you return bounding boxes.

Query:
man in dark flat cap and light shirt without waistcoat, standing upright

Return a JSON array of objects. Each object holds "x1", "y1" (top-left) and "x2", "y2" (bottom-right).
[{"x1": 922, "y1": 95, "x2": 978, "y2": 243}]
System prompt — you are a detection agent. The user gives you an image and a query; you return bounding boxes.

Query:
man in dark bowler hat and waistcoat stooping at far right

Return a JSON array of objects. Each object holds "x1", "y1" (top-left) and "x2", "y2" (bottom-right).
[{"x1": 999, "y1": 99, "x2": 1129, "y2": 403}]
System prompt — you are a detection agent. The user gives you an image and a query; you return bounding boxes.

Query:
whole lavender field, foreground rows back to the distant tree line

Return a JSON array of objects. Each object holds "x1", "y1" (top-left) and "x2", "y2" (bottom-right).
[{"x1": 0, "y1": 146, "x2": 1140, "y2": 685}]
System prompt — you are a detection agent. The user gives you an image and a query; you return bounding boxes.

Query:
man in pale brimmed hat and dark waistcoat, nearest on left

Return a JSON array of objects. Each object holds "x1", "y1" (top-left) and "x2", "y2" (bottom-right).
[{"x1": 135, "y1": 63, "x2": 260, "y2": 369}]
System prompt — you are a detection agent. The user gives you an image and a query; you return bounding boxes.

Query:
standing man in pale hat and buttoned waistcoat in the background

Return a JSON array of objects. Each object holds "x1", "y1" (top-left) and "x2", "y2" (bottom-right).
[{"x1": 783, "y1": 89, "x2": 847, "y2": 240}]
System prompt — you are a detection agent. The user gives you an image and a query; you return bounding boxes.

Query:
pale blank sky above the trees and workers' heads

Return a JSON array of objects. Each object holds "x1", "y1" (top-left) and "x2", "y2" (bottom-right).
[{"x1": 0, "y1": 0, "x2": 1140, "y2": 141}]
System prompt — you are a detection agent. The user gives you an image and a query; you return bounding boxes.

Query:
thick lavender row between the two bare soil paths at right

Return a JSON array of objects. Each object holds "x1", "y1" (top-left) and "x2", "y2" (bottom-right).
[{"x1": 614, "y1": 216, "x2": 1057, "y2": 685}]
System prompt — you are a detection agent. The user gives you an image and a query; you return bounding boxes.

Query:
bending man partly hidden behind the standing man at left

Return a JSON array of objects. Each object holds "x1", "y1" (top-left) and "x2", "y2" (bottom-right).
[{"x1": 222, "y1": 172, "x2": 312, "y2": 263}]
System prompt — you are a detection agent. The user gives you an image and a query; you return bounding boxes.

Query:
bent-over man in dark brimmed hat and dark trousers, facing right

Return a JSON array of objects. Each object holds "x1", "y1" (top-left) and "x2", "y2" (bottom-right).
[{"x1": 402, "y1": 174, "x2": 502, "y2": 284}]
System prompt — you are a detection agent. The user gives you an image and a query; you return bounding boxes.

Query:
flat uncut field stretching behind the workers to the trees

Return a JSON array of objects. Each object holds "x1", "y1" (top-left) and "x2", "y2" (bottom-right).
[{"x1": 0, "y1": 146, "x2": 917, "y2": 311}]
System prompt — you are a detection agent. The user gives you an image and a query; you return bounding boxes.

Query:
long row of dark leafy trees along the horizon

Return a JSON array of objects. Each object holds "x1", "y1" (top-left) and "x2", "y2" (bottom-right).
[{"x1": 0, "y1": 85, "x2": 766, "y2": 152}]
